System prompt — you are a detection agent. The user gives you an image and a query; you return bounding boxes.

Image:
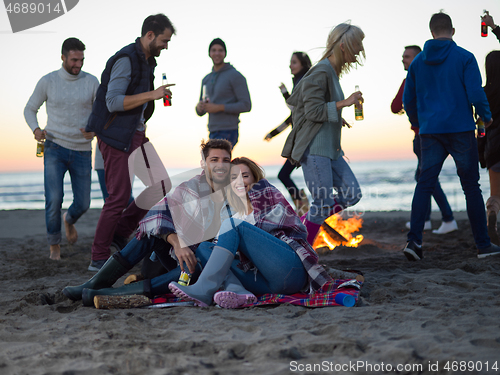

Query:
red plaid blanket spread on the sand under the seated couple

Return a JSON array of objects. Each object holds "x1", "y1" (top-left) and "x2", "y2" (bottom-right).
[{"x1": 152, "y1": 280, "x2": 362, "y2": 307}]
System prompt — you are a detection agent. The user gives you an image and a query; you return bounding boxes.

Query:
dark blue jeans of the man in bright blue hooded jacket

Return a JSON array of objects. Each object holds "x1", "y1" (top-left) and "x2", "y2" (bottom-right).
[{"x1": 408, "y1": 131, "x2": 490, "y2": 249}]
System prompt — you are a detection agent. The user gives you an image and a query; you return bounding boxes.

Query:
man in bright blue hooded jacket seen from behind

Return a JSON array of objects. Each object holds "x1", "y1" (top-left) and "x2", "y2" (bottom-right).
[{"x1": 403, "y1": 12, "x2": 500, "y2": 261}]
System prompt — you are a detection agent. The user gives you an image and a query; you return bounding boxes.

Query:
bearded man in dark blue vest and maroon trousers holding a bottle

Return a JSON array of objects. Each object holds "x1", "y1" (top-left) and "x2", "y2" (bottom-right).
[{"x1": 86, "y1": 14, "x2": 175, "y2": 271}]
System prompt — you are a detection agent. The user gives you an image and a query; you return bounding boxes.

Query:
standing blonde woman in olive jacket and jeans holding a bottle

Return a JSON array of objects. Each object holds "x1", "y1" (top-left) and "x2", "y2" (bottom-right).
[{"x1": 281, "y1": 23, "x2": 365, "y2": 244}]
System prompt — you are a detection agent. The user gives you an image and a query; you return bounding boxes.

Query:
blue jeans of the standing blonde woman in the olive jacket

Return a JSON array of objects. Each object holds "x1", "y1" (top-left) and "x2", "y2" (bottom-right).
[{"x1": 300, "y1": 150, "x2": 362, "y2": 224}]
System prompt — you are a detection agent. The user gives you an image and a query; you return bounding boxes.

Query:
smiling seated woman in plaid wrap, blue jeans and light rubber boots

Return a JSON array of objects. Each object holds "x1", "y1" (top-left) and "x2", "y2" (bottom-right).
[{"x1": 169, "y1": 158, "x2": 332, "y2": 308}]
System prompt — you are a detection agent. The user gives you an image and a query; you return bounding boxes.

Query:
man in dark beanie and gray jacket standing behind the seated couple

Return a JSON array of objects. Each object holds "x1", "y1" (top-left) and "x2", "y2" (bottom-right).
[{"x1": 196, "y1": 38, "x2": 252, "y2": 147}]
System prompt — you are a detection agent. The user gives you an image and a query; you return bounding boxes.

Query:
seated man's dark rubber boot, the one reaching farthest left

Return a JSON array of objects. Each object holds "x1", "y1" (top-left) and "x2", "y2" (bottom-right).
[{"x1": 63, "y1": 253, "x2": 132, "y2": 301}]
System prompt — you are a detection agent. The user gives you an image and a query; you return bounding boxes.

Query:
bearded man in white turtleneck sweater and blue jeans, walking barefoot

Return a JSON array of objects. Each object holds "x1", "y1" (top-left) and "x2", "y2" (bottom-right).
[{"x1": 24, "y1": 38, "x2": 99, "y2": 260}]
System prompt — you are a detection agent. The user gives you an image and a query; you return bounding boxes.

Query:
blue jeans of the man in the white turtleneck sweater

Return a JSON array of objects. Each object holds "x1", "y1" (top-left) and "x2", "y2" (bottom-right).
[{"x1": 43, "y1": 140, "x2": 92, "y2": 245}]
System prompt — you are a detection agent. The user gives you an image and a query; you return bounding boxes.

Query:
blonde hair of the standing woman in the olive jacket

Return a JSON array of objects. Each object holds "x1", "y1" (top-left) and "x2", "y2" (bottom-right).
[{"x1": 321, "y1": 23, "x2": 366, "y2": 77}]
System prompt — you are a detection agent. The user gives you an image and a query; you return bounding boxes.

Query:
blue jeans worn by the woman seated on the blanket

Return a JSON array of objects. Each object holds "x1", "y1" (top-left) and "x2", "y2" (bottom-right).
[{"x1": 196, "y1": 219, "x2": 308, "y2": 294}]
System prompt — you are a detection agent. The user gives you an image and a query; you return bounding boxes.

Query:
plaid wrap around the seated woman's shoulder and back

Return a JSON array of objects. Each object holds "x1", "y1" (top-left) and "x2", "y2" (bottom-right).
[{"x1": 240, "y1": 179, "x2": 332, "y2": 291}]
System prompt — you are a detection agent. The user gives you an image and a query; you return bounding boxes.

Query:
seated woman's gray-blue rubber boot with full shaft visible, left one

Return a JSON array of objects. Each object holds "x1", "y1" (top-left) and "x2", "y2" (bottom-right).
[{"x1": 168, "y1": 246, "x2": 234, "y2": 307}]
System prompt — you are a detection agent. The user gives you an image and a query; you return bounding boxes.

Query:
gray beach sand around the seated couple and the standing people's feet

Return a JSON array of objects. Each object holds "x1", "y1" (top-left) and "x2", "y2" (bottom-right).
[{"x1": 0, "y1": 210, "x2": 500, "y2": 375}]
